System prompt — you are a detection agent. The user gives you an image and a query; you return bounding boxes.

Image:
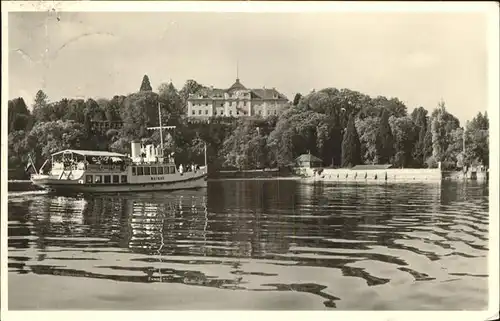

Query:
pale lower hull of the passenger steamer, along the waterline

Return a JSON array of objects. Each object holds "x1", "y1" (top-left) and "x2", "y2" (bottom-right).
[{"x1": 32, "y1": 174, "x2": 207, "y2": 193}]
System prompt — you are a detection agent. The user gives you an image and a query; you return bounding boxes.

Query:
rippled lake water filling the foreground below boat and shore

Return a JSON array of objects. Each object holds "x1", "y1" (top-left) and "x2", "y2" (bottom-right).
[{"x1": 8, "y1": 180, "x2": 488, "y2": 310}]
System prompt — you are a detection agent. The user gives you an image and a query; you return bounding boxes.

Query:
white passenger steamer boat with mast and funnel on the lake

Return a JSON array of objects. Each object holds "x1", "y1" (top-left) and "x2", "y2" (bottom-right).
[{"x1": 31, "y1": 106, "x2": 208, "y2": 193}]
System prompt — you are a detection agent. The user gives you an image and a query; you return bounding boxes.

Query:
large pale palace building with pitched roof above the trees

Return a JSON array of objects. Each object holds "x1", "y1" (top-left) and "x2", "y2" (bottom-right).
[{"x1": 187, "y1": 79, "x2": 289, "y2": 120}]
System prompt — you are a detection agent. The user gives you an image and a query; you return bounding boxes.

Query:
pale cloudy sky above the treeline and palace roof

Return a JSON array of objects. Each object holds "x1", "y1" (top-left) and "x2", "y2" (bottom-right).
[{"x1": 8, "y1": 8, "x2": 488, "y2": 124}]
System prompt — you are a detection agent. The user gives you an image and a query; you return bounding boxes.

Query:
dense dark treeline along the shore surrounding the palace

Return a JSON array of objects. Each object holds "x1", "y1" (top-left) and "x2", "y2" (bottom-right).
[{"x1": 8, "y1": 76, "x2": 489, "y2": 177}]
